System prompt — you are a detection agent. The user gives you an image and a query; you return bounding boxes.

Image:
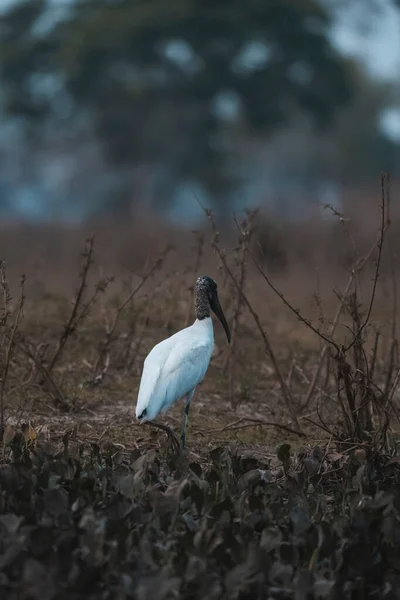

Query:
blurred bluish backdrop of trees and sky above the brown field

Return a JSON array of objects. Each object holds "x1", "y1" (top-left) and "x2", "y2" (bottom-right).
[{"x1": 0, "y1": 0, "x2": 400, "y2": 226}]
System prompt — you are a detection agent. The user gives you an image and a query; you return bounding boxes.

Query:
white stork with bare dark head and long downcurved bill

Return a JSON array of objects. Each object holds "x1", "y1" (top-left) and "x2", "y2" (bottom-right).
[{"x1": 135, "y1": 275, "x2": 231, "y2": 450}]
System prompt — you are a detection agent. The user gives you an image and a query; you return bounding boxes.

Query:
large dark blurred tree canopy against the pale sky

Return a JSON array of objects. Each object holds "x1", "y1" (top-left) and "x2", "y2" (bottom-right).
[{"x1": 0, "y1": 0, "x2": 353, "y2": 214}]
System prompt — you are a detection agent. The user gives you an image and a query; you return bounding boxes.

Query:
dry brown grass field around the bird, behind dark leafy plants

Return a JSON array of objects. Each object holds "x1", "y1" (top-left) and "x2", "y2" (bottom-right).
[{"x1": 0, "y1": 188, "x2": 399, "y2": 460}]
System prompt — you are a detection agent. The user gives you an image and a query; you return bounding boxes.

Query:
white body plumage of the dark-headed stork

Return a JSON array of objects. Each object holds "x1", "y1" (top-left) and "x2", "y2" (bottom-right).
[{"x1": 136, "y1": 317, "x2": 214, "y2": 422}]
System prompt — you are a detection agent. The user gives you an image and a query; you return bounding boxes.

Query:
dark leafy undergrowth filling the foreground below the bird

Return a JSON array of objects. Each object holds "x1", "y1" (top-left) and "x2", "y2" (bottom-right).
[{"x1": 0, "y1": 427, "x2": 400, "y2": 600}]
